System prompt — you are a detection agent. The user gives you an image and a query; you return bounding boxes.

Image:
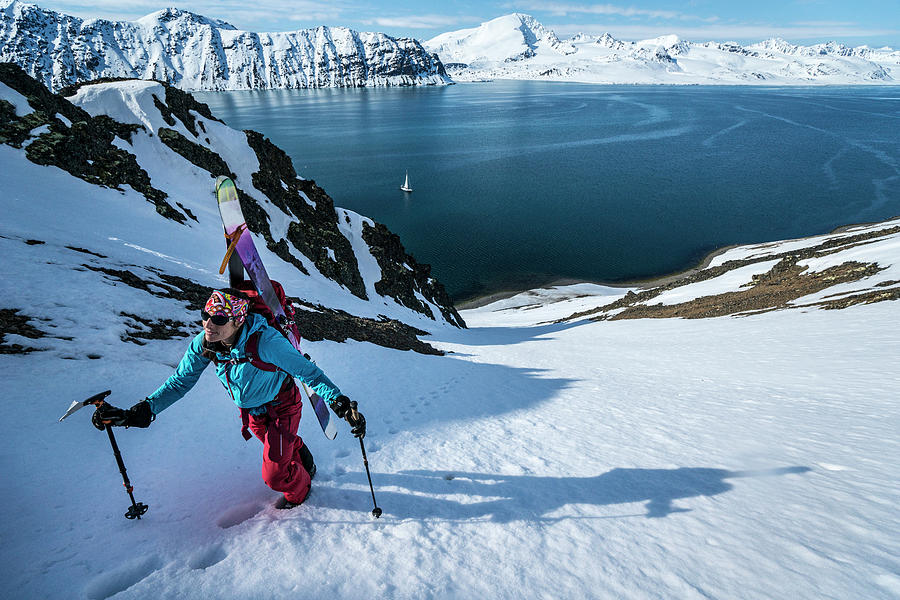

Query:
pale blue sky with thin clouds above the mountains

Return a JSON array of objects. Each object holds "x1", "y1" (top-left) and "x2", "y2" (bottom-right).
[{"x1": 14, "y1": 0, "x2": 900, "y2": 49}]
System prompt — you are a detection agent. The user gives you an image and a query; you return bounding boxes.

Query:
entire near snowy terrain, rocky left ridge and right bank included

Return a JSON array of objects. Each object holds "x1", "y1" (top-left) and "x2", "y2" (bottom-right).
[{"x1": 0, "y1": 59, "x2": 900, "y2": 600}]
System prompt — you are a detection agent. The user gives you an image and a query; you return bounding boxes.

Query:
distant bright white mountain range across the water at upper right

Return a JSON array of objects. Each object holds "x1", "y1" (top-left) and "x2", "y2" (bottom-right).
[{"x1": 425, "y1": 13, "x2": 900, "y2": 85}]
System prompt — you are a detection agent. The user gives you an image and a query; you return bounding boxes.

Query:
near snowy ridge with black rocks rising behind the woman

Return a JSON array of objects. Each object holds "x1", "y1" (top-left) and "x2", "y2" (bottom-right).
[{"x1": 0, "y1": 63, "x2": 464, "y2": 354}]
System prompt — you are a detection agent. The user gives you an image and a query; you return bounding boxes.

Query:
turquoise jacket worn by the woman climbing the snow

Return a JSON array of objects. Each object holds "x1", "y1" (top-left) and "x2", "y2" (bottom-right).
[{"x1": 147, "y1": 313, "x2": 341, "y2": 415}]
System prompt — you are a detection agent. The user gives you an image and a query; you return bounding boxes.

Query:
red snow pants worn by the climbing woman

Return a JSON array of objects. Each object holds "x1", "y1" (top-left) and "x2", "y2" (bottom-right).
[{"x1": 241, "y1": 377, "x2": 309, "y2": 504}]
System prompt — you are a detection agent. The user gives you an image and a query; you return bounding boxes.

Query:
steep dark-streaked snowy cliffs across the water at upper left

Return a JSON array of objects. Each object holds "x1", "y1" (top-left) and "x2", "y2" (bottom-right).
[{"x1": 0, "y1": 0, "x2": 449, "y2": 91}]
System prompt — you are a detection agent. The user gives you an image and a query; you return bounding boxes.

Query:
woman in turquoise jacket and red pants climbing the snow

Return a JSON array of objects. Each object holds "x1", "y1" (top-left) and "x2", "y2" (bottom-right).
[{"x1": 93, "y1": 288, "x2": 366, "y2": 508}]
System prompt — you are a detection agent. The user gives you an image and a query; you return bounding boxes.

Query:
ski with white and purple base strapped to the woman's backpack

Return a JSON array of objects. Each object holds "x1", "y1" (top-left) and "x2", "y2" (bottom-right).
[{"x1": 216, "y1": 176, "x2": 337, "y2": 440}]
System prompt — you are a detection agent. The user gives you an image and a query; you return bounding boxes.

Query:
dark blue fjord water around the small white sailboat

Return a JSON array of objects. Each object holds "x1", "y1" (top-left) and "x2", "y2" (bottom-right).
[{"x1": 195, "y1": 81, "x2": 900, "y2": 300}]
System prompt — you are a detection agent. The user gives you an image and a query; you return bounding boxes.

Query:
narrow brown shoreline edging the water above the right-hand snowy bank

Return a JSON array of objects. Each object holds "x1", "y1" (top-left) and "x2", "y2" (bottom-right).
[{"x1": 454, "y1": 215, "x2": 900, "y2": 310}]
